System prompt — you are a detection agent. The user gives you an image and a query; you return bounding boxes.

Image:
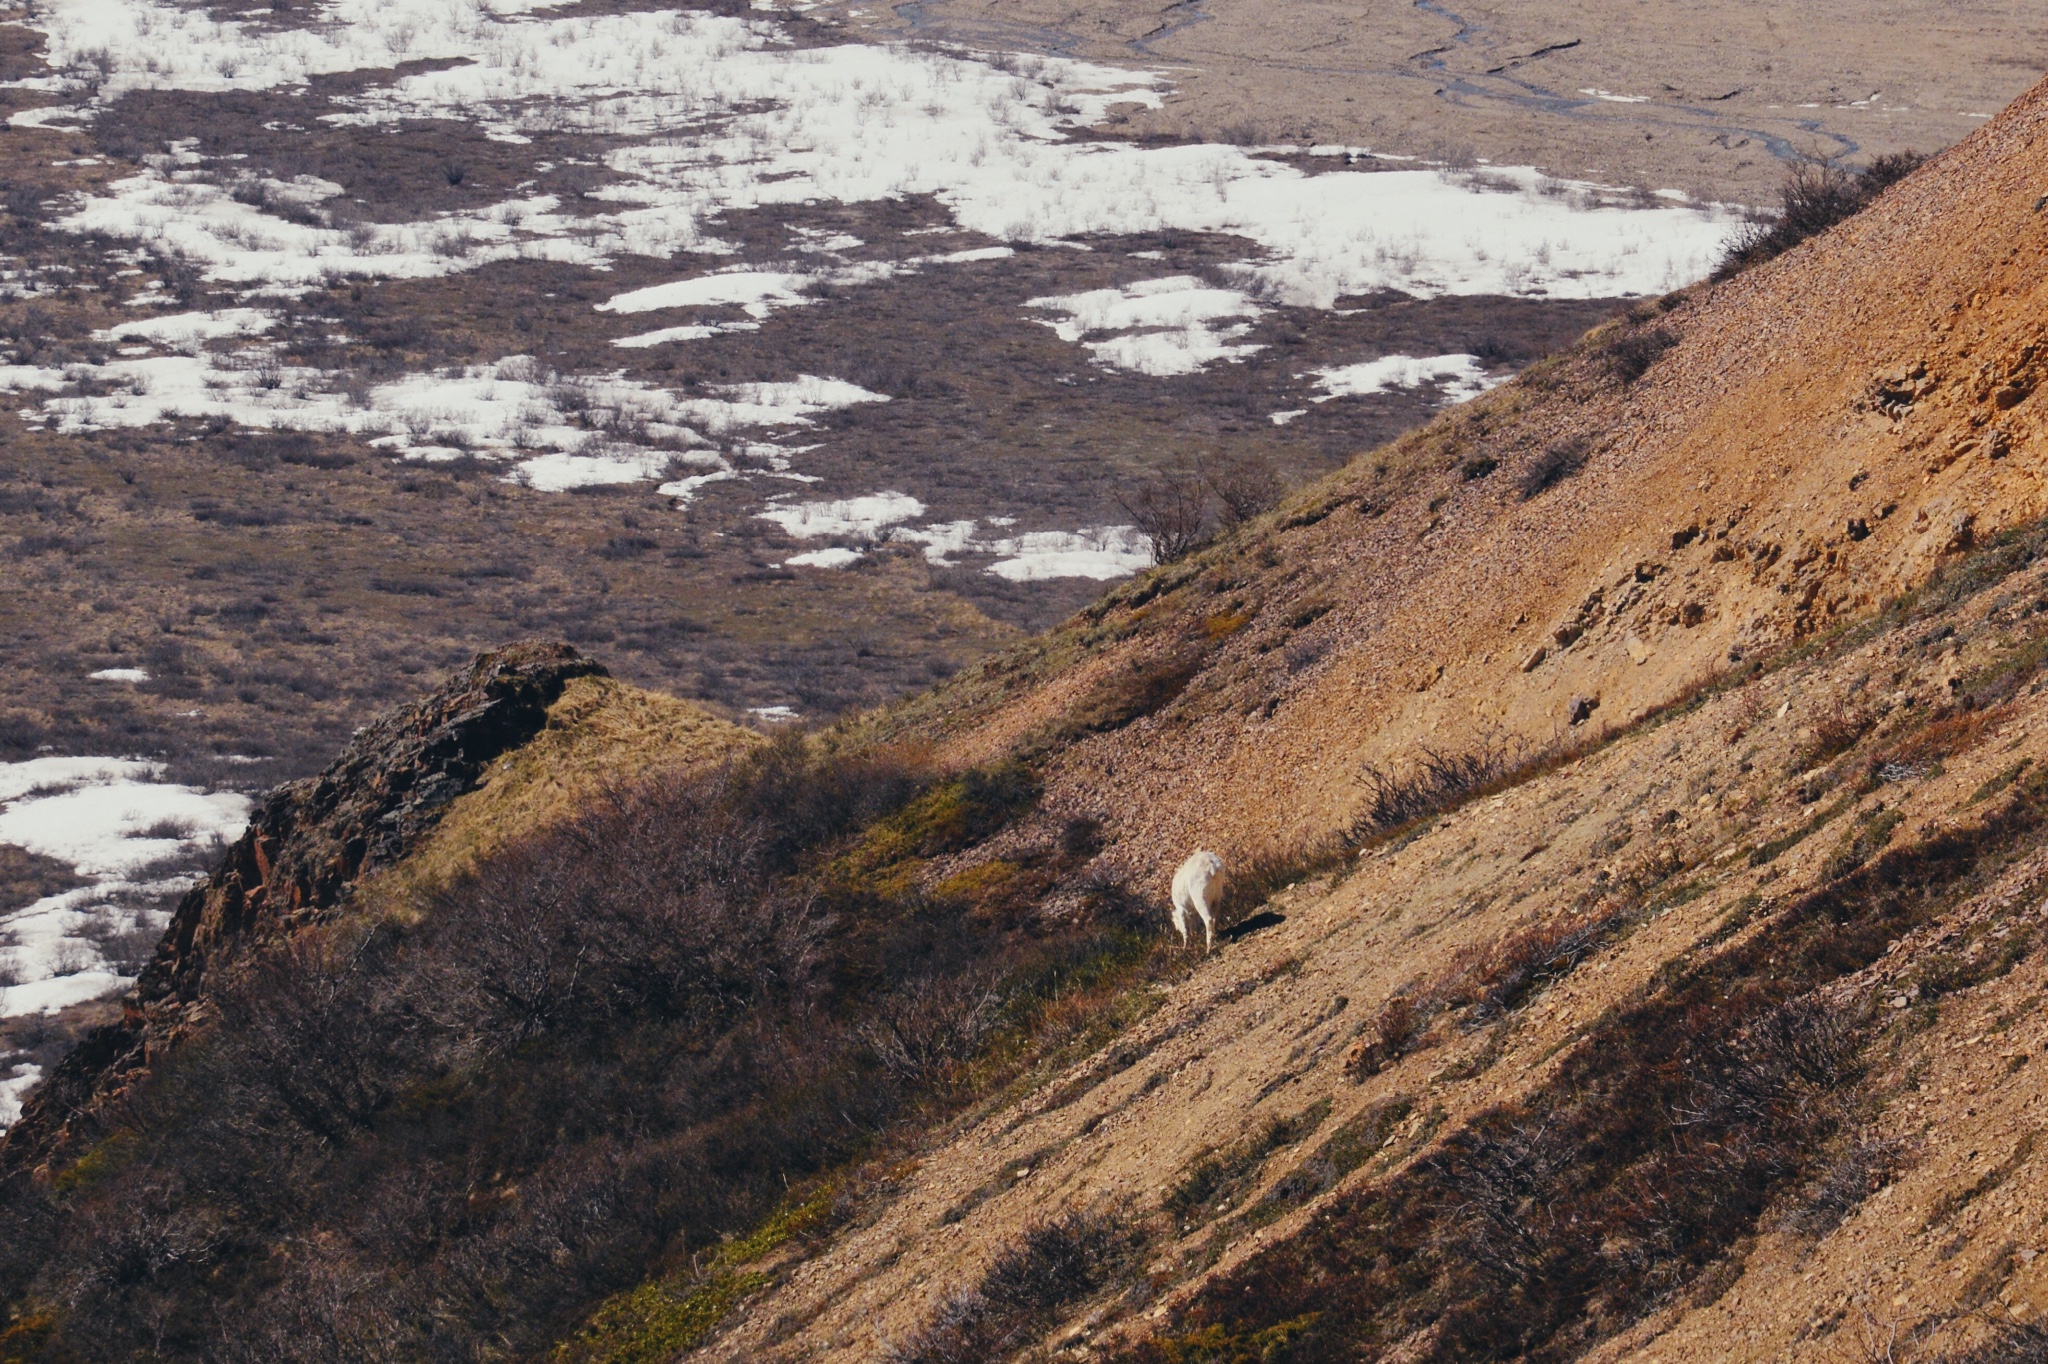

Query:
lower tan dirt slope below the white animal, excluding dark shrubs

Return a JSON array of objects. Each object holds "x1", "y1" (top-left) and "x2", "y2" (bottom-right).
[{"x1": 711, "y1": 545, "x2": 2048, "y2": 1360}]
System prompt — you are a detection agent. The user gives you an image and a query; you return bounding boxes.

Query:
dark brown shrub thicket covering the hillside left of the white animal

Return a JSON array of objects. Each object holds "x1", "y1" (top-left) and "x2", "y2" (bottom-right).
[{"x1": 0, "y1": 735, "x2": 1179, "y2": 1362}]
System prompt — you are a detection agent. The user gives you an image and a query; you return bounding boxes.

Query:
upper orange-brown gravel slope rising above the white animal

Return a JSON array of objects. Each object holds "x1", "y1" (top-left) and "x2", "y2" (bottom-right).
[{"x1": 903, "y1": 66, "x2": 2048, "y2": 892}]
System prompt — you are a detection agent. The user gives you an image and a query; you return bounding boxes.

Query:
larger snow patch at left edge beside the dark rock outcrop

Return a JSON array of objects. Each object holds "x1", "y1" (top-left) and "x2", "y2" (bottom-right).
[{"x1": 0, "y1": 758, "x2": 250, "y2": 1024}]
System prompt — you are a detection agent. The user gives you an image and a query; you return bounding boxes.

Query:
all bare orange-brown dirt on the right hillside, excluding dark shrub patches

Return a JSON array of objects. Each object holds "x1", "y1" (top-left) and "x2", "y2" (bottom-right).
[{"x1": 705, "y1": 66, "x2": 2048, "y2": 1364}]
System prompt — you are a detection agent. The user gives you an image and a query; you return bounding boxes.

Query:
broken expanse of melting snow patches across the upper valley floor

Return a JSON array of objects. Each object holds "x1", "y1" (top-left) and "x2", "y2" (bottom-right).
[{"x1": 0, "y1": 0, "x2": 1737, "y2": 582}]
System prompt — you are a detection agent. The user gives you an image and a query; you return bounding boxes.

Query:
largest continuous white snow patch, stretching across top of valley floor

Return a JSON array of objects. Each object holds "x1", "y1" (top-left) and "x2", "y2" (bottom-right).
[{"x1": 33, "y1": 0, "x2": 1737, "y2": 307}]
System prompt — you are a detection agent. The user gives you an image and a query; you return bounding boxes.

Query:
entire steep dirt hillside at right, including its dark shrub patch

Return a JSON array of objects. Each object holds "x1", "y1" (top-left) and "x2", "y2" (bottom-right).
[{"x1": 684, "y1": 74, "x2": 2048, "y2": 1360}]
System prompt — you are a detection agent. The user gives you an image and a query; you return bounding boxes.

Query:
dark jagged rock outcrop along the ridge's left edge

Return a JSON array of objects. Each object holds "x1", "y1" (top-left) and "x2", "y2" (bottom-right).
[{"x1": 0, "y1": 643, "x2": 604, "y2": 1174}]
